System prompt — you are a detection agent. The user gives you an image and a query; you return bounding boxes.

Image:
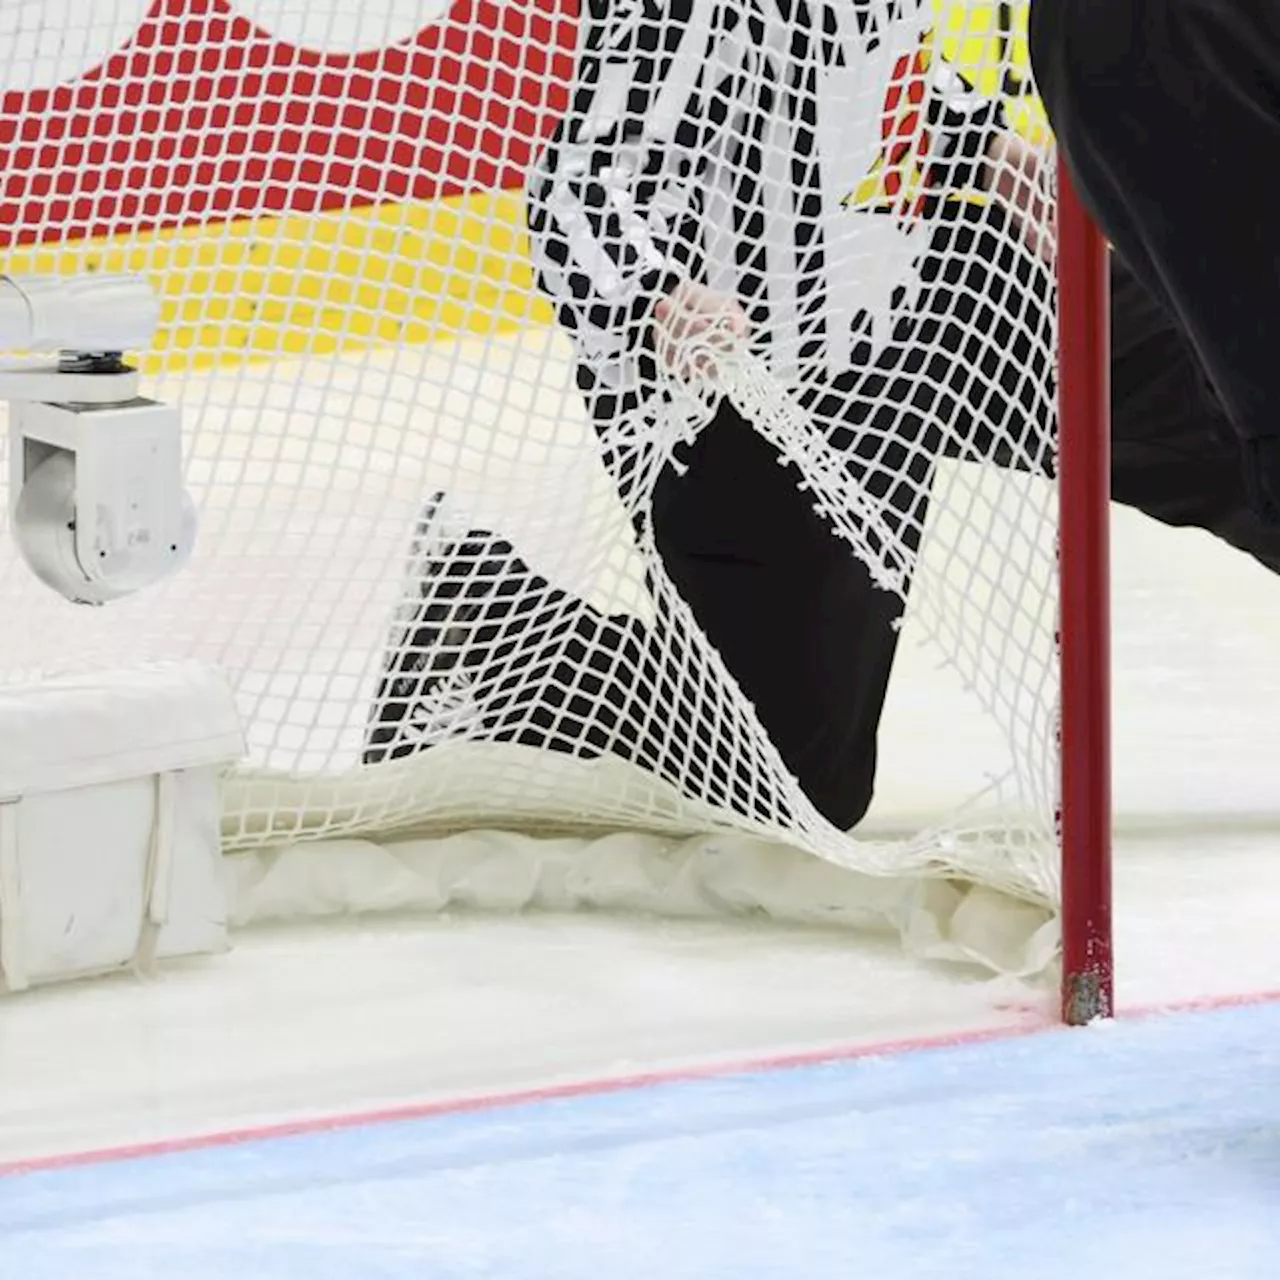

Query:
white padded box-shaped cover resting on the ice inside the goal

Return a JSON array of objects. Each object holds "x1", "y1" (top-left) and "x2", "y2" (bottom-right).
[{"x1": 0, "y1": 662, "x2": 243, "y2": 992}]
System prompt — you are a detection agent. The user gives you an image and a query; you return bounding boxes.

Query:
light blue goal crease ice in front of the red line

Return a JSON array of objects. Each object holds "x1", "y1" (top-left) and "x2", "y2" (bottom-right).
[{"x1": 0, "y1": 1006, "x2": 1280, "y2": 1280}]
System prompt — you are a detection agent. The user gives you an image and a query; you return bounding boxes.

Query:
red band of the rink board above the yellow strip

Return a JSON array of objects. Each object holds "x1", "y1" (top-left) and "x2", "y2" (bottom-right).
[{"x1": 0, "y1": 0, "x2": 577, "y2": 244}]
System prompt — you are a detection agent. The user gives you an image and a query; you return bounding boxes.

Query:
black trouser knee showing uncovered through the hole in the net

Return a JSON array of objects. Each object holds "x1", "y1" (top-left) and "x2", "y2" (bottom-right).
[{"x1": 653, "y1": 402, "x2": 901, "y2": 827}]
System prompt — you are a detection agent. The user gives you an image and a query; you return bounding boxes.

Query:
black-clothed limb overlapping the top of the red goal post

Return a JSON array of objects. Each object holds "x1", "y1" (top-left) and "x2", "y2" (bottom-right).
[{"x1": 1030, "y1": 0, "x2": 1280, "y2": 455}]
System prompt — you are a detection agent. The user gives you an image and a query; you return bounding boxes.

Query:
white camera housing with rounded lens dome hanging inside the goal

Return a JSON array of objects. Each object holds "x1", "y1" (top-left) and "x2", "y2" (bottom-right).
[{"x1": 0, "y1": 275, "x2": 196, "y2": 604}]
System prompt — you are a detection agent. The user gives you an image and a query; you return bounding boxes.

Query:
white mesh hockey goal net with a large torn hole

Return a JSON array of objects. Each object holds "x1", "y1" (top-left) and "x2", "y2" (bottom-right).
[{"x1": 0, "y1": 0, "x2": 1111, "y2": 1008}]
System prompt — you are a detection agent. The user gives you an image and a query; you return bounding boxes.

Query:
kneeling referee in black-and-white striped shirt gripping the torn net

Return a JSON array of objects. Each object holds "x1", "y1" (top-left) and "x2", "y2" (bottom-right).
[{"x1": 366, "y1": 0, "x2": 1280, "y2": 828}]
